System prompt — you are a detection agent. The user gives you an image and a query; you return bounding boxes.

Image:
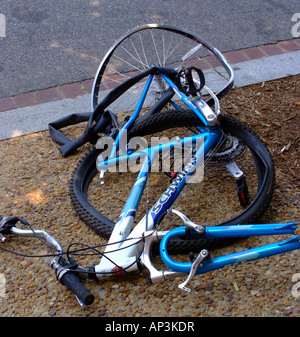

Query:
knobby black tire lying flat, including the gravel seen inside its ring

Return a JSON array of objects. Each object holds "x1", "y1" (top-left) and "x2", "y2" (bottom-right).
[{"x1": 70, "y1": 110, "x2": 275, "y2": 253}]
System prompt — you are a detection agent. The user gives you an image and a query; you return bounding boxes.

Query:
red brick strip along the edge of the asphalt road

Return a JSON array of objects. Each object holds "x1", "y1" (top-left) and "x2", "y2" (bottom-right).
[{"x1": 0, "y1": 38, "x2": 300, "y2": 112}]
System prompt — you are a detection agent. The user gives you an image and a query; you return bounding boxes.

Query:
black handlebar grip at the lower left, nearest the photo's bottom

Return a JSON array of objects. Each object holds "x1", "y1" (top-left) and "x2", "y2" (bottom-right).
[{"x1": 59, "y1": 272, "x2": 95, "y2": 305}]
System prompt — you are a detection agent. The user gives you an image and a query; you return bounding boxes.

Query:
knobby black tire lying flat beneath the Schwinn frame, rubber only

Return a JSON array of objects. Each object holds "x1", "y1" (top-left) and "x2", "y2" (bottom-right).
[{"x1": 70, "y1": 110, "x2": 275, "y2": 253}]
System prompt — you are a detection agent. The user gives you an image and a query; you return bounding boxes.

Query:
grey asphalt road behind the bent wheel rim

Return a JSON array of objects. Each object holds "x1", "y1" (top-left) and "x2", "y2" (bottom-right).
[{"x1": 0, "y1": 0, "x2": 300, "y2": 98}]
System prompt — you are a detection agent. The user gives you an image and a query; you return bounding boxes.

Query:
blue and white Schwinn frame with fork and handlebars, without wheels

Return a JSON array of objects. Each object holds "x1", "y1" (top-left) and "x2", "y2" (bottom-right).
[{"x1": 0, "y1": 65, "x2": 300, "y2": 306}]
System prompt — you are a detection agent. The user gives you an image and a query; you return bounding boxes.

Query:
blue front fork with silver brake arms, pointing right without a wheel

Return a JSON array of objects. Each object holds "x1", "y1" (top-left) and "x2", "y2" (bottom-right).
[{"x1": 141, "y1": 210, "x2": 300, "y2": 292}]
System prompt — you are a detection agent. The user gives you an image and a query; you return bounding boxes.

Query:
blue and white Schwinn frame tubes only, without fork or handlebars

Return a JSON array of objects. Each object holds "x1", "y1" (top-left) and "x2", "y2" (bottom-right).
[{"x1": 95, "y1": 68, "x2": 222, "y2": 273}]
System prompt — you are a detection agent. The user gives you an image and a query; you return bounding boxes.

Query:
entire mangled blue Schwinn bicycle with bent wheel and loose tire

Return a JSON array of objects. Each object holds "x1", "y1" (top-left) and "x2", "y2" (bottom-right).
[{"x1": 0, "y1": 25, "x2": 300, "y2": 304}]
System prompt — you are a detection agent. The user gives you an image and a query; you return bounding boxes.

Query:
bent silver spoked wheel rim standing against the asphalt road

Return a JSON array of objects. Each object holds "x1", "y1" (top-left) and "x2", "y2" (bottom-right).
[{"x1": 91, "y1": 24, "x2": 233, "y2": 121}]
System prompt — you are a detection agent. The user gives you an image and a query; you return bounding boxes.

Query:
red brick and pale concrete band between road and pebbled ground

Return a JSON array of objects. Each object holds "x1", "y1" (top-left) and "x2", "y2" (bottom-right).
[{"x1": 0, "y1": 39, "x2": 300, "y2": 140}]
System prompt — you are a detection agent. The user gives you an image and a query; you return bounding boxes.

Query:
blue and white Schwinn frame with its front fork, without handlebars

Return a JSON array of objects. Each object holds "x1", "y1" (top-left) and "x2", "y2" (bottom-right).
[{"x1": 94, "y1": 67, "x2": 300, "y2": 282}]
